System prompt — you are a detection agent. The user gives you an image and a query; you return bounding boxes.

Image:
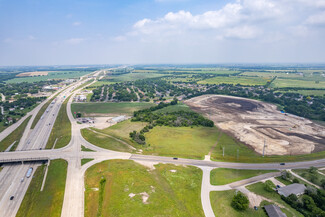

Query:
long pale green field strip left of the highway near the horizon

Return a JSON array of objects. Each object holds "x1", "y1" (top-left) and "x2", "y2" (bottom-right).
[{"x1": 6, "y1": 71, "x2": 90, "y2": 83}]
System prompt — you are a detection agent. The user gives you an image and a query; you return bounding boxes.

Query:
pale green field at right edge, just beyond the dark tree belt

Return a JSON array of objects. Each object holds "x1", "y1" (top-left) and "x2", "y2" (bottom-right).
[{"x1": 271, "y1": 79, "x2": 325, "y2": 89}]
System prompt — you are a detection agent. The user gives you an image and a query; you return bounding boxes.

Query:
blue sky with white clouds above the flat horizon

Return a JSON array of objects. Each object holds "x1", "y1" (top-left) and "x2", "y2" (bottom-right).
[{"x1": 0, "y1": 0, "x2": 325, "y2": 66}]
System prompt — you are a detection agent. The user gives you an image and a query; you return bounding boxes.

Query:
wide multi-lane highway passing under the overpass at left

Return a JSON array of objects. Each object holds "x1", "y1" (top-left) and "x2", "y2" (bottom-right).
[{"x1": 0, "y1": 70, "x2": 100, "y2": 216}]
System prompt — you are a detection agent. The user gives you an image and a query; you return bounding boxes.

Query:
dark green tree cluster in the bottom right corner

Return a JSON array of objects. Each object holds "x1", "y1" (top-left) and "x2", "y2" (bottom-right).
[{"x1": 281, "y1": 187, "x2": 325, "y2": 217}]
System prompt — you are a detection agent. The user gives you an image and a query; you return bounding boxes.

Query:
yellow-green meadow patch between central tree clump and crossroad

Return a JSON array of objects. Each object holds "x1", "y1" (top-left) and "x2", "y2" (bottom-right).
[{"x1": 143, "y1": 126, "x2": 218, "y2": 159}]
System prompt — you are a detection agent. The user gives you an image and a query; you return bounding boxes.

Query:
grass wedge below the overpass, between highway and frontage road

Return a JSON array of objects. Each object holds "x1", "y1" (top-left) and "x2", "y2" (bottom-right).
[{"x1": 17, "y1": 159, "x2": 68, "y2": 217}]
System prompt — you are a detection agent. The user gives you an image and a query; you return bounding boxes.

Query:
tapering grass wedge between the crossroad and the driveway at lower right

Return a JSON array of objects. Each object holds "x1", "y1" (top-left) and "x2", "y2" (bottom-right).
[{"x1": 210, "y1": 168, "x2": 274, "y2": 185}]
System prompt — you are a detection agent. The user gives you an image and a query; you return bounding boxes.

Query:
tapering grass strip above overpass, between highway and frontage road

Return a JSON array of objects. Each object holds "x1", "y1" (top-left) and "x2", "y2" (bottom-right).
[{"x1": 46, "y1": 97, "x2": 71, "y2": 149}]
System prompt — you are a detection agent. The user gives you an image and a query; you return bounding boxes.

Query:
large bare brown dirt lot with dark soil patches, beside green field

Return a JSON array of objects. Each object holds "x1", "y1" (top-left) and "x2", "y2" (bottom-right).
[{"x1": 185, "y1": 95, "x2": 325, "y2": 155}]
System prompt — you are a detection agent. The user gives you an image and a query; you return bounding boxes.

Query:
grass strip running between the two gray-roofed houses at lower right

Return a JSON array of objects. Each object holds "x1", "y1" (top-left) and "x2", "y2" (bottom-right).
[{"x1": 246, "y1": 182, "x2": 303, "y2": 217}]
